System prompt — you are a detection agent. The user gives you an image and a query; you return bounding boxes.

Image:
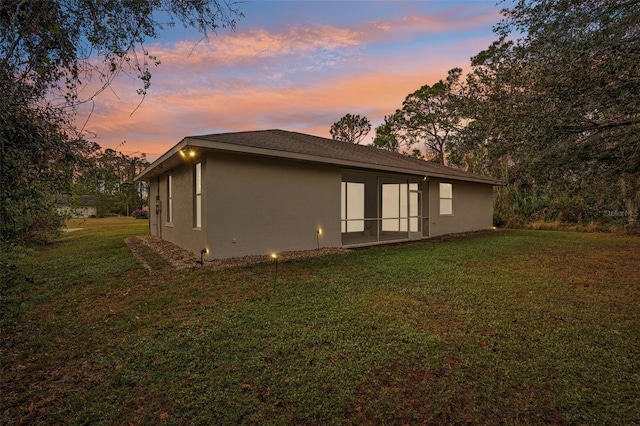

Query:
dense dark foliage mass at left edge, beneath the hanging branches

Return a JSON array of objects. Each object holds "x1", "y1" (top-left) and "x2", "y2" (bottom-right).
[{"x1": 0, "y1": 76, "x2": 92, "y2": 247}]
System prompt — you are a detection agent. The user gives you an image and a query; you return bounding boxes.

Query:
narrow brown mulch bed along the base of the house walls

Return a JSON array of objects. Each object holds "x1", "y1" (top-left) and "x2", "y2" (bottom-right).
[{"x1": 127, "y1": 235, "x2": 350, "y2": 271}]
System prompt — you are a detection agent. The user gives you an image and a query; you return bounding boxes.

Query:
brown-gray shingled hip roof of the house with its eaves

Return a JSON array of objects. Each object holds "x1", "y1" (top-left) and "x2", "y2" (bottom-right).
[{"x1": 136, "y1": 130, "x2": 499, "y2": 185}]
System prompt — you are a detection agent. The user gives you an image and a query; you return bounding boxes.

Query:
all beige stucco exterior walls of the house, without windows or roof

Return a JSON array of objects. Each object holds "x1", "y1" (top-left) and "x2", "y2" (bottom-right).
[{"x1": 149, "y1": 155, "x2": 493, "y2": 260}]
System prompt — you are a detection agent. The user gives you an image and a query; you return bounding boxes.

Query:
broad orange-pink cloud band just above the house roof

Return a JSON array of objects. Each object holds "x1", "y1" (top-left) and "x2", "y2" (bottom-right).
[{"x1": 81, "y1": 61, "x2": 460, "y2": 157}]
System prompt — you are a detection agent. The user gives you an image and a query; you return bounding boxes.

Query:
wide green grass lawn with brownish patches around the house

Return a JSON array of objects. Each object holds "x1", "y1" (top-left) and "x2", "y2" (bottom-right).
[{"x1": 0, "y1": 219, "x2": 640, "y2": 425}]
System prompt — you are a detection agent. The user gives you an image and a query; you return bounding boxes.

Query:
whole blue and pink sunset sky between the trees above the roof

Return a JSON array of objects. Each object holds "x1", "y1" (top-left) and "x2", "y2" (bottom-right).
[{"x1": 78, "y1": 0, "x2": 502, "y2": 160}]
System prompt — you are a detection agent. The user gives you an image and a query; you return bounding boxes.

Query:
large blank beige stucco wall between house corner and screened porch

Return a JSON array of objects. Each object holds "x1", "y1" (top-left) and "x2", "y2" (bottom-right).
[{"x1": 204, "y1": 153, "x2": 341, "y2": 259}]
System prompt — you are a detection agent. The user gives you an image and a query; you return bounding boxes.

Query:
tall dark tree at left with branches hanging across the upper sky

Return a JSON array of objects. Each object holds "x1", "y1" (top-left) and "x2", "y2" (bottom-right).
[{"x1": 0, "y1": 0, "x2": 241, "y2": 245}]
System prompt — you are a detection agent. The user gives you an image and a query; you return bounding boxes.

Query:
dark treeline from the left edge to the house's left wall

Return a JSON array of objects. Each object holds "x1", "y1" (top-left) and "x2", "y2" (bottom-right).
[{"x1": 0, "y1": 133, "x2": 149, "y2": 244}]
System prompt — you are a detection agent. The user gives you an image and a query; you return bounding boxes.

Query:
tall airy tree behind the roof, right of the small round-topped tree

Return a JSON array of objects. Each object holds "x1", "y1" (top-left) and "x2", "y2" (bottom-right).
[{"x1": 395, "y1": 68, "x2": 464, "y2": 164}]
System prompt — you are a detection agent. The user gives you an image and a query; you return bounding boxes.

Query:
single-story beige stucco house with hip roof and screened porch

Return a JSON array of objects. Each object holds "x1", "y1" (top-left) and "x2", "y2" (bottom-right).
[{"x1": 136, "y1": 130, "x2": 498, "y2": 260}]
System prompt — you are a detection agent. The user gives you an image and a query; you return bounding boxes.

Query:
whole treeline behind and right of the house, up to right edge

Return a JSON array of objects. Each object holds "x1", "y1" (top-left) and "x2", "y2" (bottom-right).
[{"x1": 332, "y1": 0, "x2": 640, "y2": 231}]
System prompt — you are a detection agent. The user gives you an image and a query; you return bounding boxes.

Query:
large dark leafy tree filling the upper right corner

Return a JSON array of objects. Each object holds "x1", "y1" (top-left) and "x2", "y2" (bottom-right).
[{"x1": 470, "y1": 0, "x2": 640, "y2": 225}]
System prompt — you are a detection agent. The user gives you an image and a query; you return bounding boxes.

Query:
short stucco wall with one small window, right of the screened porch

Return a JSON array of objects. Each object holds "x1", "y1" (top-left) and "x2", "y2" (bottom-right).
[{"x1": 429, "y1": 179, "x2": 493, "y2": 237}]
